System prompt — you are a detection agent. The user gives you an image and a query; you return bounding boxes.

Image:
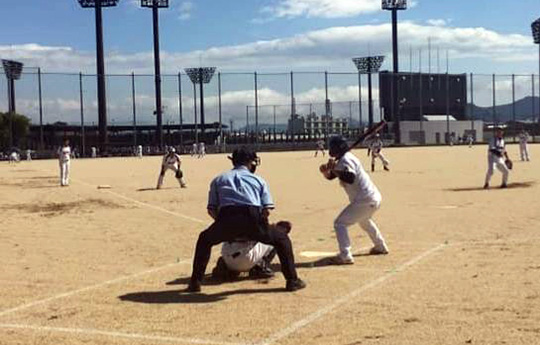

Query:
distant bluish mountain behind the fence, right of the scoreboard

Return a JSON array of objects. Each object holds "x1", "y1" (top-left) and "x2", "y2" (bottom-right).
[{"x1": 473, "y1": 96, "x2": 540, "y2": 122}]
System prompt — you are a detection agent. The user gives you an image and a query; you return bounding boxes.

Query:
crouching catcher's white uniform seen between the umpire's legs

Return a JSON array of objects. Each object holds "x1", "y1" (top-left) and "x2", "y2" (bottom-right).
[{"x1": 221, "y1": 241, "x2": 274, "y2": 272}]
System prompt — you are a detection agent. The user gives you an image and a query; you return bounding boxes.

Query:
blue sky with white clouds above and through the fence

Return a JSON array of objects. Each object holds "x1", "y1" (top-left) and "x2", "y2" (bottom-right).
[{"x1": 0, "y1": 0, "x2": 540, "y2": 125}]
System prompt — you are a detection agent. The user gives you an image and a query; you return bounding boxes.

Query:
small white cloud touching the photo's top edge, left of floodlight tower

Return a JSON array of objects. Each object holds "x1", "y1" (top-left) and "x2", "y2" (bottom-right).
[{"x1": 261, "y1": 0, "x2": 381, "y2": 18}]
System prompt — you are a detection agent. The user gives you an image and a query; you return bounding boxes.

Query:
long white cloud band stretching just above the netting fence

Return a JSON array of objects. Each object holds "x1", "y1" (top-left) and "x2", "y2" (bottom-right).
[{"x1": 0, "y1": 22, "x2": 537, "y2": 74}]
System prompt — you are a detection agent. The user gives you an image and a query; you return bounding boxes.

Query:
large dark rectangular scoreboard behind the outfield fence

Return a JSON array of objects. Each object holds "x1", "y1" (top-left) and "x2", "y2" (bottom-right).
[{"x1": 379, "y1": 71, "x2": 467, "y2": 121}]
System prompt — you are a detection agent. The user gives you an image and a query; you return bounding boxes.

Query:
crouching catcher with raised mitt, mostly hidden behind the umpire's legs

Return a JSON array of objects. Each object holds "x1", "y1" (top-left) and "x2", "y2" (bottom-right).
[{"x1": 212, "y1": 221, "x2": 292, "y2": 280}]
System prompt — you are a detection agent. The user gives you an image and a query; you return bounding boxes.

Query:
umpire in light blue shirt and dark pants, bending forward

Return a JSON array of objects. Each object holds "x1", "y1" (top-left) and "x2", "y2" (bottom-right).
[{"x1": 187, "y1": 147, "x2": 306, "y2": 292}]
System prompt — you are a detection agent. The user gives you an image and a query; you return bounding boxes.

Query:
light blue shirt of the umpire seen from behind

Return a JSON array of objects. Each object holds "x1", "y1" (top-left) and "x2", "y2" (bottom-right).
[{"x1": 208, "y1": 165, "x2": 274, "y2": 210}]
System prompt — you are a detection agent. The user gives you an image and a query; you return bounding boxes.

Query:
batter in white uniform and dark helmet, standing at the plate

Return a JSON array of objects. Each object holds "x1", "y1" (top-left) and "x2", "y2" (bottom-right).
[{"x1": 319, "y1": 136, "x2": 388, "y2": 265}]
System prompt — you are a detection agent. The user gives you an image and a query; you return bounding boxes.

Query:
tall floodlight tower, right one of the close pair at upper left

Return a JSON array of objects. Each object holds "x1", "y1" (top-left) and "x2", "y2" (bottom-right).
[{"x1": 141, "y1": 0, "x2": 169, "y2": 148}]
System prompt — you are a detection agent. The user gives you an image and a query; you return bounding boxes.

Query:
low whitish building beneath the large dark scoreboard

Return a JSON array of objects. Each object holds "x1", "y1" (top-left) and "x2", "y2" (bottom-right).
[{"x1": 400, "y1": 115, "x2": 484, "y2": 145}]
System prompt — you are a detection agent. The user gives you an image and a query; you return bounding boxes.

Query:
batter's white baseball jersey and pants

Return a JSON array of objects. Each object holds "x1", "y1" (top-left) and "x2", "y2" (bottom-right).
[{"x1": 334, "y1": 152, "x2": 388, "y2": 261}]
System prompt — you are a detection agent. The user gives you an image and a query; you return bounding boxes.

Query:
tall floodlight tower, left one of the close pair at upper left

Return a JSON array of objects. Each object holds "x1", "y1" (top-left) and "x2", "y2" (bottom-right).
[{"x1": 78, "y1": 0, "x2": 119, "y2": 152}]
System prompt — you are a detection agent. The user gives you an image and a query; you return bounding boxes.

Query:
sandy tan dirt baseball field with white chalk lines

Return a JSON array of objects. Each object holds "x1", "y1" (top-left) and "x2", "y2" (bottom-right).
[{"x1": 0, "y1": 145, "x2": 540, "y2": 345}]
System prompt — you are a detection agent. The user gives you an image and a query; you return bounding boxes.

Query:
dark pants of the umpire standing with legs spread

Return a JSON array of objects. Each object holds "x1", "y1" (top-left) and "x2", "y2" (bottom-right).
[{"x1": 191, "y1": 206, "x2": 298, "y2": 282}]
